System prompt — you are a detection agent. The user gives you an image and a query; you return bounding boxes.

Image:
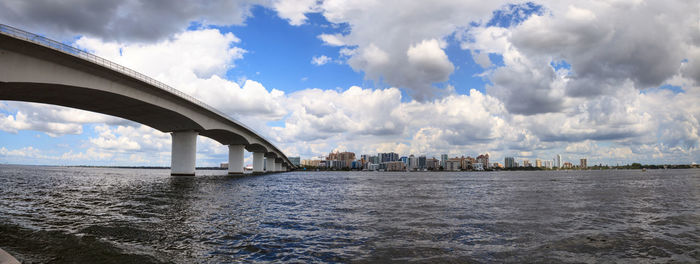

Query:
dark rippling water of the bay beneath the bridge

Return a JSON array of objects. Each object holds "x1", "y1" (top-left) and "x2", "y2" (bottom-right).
[{"x1": 0, "y1": 166, "x2": 700, "y2": 263}]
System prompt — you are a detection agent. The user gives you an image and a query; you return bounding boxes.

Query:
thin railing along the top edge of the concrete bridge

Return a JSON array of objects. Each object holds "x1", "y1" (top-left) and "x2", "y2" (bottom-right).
[{"x1": 0, "y1": 24, "x2": 292, "y2": 167}]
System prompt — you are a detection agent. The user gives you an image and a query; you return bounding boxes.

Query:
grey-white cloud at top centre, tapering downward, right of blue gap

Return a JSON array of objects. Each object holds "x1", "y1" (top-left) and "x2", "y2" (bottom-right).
[{"x1": 318, "y1": 1, "x2": 502, "y2": 101}]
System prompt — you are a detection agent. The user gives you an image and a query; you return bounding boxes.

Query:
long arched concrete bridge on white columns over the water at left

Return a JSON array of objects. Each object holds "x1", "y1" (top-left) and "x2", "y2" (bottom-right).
[{"x1": 0, "y1": 24, "x2": 295, "y2": 176}]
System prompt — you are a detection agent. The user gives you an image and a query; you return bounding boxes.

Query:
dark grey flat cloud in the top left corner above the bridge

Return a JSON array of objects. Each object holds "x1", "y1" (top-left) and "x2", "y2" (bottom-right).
[{"x1": 0, "y1": 0, "x2": 266, "y2": 41}]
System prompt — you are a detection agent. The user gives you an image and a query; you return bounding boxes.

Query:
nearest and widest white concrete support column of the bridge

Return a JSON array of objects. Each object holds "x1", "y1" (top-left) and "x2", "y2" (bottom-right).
[{"x1": 170, "y1": 131, "x2": 199, "y2": 176}]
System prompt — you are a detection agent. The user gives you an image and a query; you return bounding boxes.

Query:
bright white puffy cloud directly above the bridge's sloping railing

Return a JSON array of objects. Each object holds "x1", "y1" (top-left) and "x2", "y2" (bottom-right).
[{"x1": 76, "y1": 29, "x2": 285, "y2": 119}]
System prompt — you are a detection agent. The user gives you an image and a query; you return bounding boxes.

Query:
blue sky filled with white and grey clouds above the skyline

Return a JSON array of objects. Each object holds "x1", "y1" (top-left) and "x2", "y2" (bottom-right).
[{"x1": 0, "y1": 0, "x2": 700, "y2": 166}]
